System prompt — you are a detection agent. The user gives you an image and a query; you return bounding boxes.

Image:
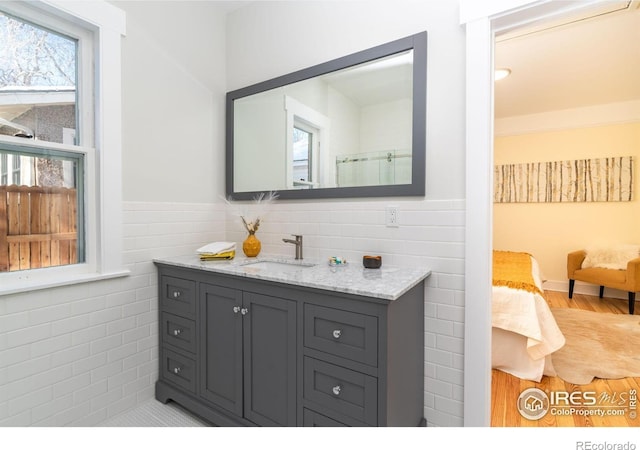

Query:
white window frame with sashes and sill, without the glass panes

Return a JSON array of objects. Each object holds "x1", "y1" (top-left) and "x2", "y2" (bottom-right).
[{"x1": 0, "y1": 0, "x2": 129, "y2": 296}]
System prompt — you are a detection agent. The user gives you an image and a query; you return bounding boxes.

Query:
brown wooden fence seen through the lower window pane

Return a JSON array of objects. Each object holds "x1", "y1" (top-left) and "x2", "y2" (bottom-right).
[{"x1": 0, "y1": 185, "x2": 78, "y2": 272}]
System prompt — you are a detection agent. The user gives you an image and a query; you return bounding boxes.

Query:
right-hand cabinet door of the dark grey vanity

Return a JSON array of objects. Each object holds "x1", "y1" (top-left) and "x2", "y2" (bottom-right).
[{"x1": 243, "y1": 292, "x2": 297, "y2": 426}]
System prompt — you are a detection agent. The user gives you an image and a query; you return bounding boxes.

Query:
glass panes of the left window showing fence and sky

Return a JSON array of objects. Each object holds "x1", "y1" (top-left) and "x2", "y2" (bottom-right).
[{"x1": 0, "y1": 7, "x2": 86, "y2": 272}]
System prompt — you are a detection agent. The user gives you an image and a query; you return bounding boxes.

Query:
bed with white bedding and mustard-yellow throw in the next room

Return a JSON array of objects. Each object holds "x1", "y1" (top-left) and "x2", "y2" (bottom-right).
[{"x1": 491, "y1": 250, "x2": 565, "y2": 382}]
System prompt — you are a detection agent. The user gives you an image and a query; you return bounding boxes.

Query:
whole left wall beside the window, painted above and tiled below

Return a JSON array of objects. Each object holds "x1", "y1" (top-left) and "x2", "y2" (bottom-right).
[{"x1": 0, "y1": 2, "x2": 230, "y2": 426}]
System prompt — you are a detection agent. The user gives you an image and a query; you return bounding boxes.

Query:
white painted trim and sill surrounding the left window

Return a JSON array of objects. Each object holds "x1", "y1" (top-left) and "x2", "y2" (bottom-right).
[{"x1": 0, "y1": 0, "x2": 129, "y2": 296}]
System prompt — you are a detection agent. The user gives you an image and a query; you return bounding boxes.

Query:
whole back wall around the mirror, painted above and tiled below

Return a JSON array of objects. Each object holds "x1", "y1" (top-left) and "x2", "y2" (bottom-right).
[{"x1": 227, "y1": 1, "x2": 465, "y2": 426}]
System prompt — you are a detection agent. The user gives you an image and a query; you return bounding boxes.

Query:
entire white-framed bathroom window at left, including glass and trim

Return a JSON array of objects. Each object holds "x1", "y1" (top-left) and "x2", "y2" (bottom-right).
[{"x1": 0, "y1": 0, "x2": 126, "y2": 295}]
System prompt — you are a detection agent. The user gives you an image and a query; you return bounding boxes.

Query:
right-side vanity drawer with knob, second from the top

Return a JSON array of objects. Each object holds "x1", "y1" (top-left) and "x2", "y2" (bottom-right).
[{"x1": 303, "y1": 357, "x2": 378, "y2": 426}]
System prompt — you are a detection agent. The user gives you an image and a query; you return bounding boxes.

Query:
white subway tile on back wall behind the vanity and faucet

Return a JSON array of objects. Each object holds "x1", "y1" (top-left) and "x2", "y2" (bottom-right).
[{"x1": 227, "y1": 199, "x2": 465, "y2": 426}]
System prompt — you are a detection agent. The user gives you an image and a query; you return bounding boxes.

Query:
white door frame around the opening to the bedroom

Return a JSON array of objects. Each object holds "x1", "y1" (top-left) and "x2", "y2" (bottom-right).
[{"x1": 460, "y1": 0, "x2": 605, "y2": 427}]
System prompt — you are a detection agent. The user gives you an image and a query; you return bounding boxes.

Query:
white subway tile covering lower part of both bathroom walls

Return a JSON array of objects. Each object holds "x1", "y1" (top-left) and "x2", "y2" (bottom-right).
[{"x1": 0, "y1": 199, "x2": 464, "y2": 426}]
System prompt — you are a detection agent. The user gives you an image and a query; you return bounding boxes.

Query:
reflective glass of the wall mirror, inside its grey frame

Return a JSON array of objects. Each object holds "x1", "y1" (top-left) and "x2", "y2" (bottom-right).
[{"x1": 233, "y1": 50, "x2": 413, "y2": 192}]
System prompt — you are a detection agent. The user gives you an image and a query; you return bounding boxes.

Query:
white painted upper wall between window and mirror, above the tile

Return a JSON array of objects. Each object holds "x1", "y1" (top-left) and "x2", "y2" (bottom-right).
[{"x1": 119, "y1": 1, "x2": 225, "y2": 202}]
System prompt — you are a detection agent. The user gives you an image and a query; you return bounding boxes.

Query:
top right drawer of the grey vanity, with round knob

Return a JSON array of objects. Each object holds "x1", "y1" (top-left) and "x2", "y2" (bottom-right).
[{"x1": 304, "y1": 303, "x2": 378, "y2": 367}]
